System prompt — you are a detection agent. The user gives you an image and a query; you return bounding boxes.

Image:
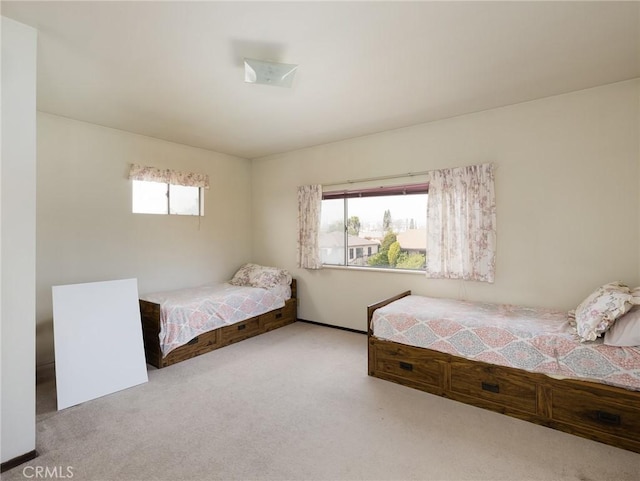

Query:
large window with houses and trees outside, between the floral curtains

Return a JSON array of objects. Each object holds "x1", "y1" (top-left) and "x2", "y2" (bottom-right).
[{"x1": 319, "y1": 183, "x2": 428, "y2": 271}]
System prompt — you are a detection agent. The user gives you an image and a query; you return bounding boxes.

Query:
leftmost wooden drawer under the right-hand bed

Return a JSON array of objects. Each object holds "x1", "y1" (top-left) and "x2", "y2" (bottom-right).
[{"x1": 374, "y1": 341, "x2": 443, "y2": 388}]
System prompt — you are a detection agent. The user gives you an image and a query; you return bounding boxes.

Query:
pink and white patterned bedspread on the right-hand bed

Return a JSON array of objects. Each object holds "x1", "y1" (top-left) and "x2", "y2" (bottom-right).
[{"x1": 371, "y1": 296, "x2": 640, "y2": 391}]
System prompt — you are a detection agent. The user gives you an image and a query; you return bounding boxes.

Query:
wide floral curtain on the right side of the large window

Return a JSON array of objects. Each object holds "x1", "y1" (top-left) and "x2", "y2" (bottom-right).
[{"x1": 426, "y1": 164, "x2": 496, "y2": 282}]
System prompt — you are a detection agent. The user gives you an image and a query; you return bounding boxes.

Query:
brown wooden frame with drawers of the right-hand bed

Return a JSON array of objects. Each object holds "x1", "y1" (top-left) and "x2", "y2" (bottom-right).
[{"x1": 367, "y1": 291, "x2": 640, "y2": 453}]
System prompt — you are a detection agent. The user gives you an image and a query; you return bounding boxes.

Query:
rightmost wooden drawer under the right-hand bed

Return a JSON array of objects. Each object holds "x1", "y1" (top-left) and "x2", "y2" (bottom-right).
[{"x1": 552, "y1": 387, "x2": 640, "y2": 441}]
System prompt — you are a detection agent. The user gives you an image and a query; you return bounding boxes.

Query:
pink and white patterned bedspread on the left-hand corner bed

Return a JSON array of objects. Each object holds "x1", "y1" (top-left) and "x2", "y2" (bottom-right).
[{"x1": 141, "y1": 283, "x2": 291, "y2": 356}]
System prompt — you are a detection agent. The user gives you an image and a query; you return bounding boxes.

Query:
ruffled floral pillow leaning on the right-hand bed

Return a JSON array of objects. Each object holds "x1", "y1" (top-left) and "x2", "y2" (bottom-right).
[{"x1": 576, "y1": 281, "x2": 633, "y2": 341}]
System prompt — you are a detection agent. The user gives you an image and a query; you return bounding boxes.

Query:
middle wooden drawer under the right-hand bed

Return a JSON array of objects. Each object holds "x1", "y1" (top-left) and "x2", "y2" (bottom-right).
[{"x1": 451, "y1": 361, "x2": 536, "y2": 414}]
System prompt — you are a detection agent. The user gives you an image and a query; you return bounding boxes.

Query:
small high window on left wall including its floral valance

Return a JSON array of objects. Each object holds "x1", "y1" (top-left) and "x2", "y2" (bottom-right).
[{"x1": 129, "y1": 165, "x2": 209, "y2": 216}]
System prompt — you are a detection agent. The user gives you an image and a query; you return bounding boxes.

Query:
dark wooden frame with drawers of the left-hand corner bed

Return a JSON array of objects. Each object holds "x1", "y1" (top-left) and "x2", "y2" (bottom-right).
[{"x1": 140, "y1": 279, "x2": 298, "y2": 369}]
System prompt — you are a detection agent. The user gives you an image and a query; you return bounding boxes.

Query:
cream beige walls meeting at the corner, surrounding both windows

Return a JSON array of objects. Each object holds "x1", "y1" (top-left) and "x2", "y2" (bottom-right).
[{"x1": 36, "y1": 80, "x2": 640, "y2": 365}]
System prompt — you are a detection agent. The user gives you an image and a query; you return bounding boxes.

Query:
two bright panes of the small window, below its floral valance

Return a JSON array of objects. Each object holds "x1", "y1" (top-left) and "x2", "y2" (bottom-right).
[{"x1": 132, "y1": 180, "x2": 204, "y2": 216}]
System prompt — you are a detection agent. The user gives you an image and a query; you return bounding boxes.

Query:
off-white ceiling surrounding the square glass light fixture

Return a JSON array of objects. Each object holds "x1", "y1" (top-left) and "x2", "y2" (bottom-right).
[{"x1": 1, "y1": 0, "x2": 640, "y2": 158}]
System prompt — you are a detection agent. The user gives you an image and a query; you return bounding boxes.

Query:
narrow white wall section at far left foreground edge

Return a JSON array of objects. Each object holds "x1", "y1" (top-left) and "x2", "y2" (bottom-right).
[{"x1": 0, "y1": 17, "x2": 37, "y2": 463}]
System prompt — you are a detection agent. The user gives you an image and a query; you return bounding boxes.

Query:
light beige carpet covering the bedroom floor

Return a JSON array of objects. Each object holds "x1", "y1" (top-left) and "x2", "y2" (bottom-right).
[{"x1": 2, "y1": 322, "x2": 640, "y2": 481}]
